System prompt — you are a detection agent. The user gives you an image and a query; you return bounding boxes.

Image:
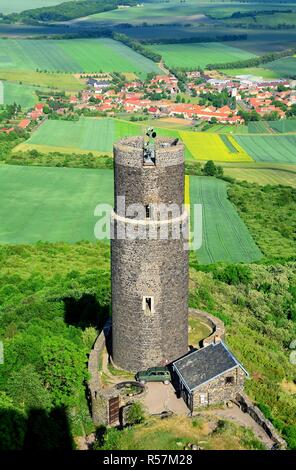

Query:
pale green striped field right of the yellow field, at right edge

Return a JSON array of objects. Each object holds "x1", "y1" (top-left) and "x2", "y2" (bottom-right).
[{"x1": 234, "y1": 135, "x2": 296, "y2": 165}]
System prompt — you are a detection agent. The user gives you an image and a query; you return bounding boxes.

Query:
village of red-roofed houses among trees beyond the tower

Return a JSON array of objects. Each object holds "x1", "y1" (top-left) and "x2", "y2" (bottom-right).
[{"x1": 0, "y1": 71, "x2": 296, "y2": 134}]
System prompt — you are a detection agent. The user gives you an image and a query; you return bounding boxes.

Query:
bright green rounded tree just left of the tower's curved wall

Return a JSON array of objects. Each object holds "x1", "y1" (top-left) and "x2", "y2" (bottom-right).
[{"x1": 42, "y1": 336, "x2": 87, "y2": 406}]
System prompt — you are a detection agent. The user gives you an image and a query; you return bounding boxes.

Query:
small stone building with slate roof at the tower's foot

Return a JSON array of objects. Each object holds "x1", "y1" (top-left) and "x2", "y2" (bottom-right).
[{"x1": 173, "y1": 341, "x2": 249, "y2": 411}]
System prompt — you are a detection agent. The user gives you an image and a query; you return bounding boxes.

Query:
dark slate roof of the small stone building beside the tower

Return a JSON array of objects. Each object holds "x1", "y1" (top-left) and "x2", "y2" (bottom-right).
[{"x1": 173, "y1": 341, "x2": 249, "y2": 391}]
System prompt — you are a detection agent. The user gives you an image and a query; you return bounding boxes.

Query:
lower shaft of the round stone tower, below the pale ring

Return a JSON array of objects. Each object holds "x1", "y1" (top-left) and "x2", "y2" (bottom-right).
[{"x1": 111, "y1": 240, "x2": 188, "y2": 372}]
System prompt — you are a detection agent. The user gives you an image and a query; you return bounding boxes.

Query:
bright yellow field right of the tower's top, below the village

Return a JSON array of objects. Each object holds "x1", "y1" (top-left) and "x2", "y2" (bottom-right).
[{"x1": 180, "y1": 131, "x2": 253, "y2": 162}]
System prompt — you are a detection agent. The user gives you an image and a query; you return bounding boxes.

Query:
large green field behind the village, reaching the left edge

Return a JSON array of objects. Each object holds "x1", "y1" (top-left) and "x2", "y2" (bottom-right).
[{"x1": 0, "y1": 38, "x2": 159, "y2": 76}]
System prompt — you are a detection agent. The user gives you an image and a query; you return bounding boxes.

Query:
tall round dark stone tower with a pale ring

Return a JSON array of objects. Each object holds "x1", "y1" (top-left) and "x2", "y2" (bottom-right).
[{"x1": 111, "y1": 137, "x2": 188, "y2": 372}]
